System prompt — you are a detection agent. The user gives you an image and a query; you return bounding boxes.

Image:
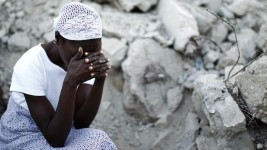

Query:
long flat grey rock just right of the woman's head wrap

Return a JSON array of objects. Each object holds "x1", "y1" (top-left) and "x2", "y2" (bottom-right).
[{"x1": 101, "y1": 9, "x2": 160, "y2": 41}]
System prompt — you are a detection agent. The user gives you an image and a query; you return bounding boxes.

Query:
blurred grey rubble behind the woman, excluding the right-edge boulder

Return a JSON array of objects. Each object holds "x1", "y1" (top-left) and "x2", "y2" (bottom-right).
[{"x1": 0, "y1": 0, "x2": 267, "y2": 150}]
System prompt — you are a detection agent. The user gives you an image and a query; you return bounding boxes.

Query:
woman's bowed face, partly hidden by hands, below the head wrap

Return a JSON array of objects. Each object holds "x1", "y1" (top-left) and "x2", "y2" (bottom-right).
[{"x1": 58, "y1": 39, "x2": 102, "y2": 66}]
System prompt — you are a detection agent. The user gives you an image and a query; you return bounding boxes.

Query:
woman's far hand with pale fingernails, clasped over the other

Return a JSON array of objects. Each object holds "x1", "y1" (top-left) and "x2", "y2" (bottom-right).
[{"x1": 84, "y1": 51, "x2": 111, "y2": 78}]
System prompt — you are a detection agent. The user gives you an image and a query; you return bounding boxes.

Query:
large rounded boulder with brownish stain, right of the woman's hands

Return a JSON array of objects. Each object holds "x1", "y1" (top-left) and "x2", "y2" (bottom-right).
[{"x1": 122, "y1": 39, "x2": 183, "y2": 120}]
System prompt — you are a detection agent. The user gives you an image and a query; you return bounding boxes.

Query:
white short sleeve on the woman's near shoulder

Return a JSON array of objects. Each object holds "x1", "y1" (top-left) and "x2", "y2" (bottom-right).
[{"x1": 10, "y1": 55, "x2": 45, "y2": 96}]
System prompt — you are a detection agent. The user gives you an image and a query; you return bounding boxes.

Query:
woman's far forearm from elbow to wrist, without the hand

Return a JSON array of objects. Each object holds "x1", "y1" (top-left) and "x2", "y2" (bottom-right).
[{"x1": 74, "y1": 77, "x2": 105, "y2": 128}]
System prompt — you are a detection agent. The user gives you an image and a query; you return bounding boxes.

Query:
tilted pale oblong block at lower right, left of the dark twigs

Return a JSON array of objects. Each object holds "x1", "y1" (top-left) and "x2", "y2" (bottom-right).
[{"x1": 194, "y1": 74, "x2": 254, "y2": 150}]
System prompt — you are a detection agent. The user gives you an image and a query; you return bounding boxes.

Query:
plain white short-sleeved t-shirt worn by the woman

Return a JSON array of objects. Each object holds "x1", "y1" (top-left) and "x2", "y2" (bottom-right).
[{"x1": 10, "y1": 44, "x2": 94, "y2": 110}]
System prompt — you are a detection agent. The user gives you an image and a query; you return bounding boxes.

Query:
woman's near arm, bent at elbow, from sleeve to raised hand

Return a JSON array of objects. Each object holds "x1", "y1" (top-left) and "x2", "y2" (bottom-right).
[{"x1": 24, "y1": 49, "x2": 92, "y2": 147}]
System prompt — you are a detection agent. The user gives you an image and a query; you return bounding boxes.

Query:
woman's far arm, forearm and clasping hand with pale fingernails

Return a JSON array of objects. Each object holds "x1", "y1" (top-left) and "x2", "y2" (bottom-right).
[{"x1": 74, "y1": 48, "x2": 111, "y2": 129}]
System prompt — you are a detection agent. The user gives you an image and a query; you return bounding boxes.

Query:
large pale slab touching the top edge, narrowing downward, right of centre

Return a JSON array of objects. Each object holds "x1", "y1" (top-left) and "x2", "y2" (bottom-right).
[{"x1": 158, "y1": 0, "x2": 199, "y2": 51}]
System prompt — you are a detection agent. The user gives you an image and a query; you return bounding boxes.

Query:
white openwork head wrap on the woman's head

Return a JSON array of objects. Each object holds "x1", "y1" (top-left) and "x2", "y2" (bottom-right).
[{"x1": 53, "y1": 2, "x2": 102, "y2": 41}]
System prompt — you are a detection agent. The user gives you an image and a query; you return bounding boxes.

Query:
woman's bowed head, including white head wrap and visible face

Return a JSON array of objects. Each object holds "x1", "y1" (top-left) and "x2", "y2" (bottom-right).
[{"x1": 54, "y1": 2, "x2": 102, "y2": 65}]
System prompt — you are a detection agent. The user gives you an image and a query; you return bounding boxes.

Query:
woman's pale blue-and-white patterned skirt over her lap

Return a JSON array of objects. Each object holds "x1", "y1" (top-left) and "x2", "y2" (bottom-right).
[{"x1": 0, "y1": 99, "x2": 117, "y2": 150}]
